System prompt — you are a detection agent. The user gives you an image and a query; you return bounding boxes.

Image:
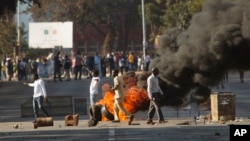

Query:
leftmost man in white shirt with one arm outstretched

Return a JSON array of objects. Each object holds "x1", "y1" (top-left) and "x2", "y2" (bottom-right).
[{"x1": 24, "y1": 74, "x2": 49, "y2": 122}]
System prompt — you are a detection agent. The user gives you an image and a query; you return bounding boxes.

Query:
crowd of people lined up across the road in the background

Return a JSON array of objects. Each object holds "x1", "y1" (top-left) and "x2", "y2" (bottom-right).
[{"x1": 0, "y1": 51, "x2": 153, "y2": 82}]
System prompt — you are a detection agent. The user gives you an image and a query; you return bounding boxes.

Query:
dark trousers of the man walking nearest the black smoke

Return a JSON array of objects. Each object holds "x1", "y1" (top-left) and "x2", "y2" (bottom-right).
[{"x1": 148, "y1": 93, "x2": 164, "y2": 121}]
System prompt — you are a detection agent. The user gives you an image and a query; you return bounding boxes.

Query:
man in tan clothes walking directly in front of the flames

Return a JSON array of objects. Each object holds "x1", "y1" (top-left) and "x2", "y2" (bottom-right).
[{"x1": 111, "y1": 70, "x2": 134, "y2": 125}]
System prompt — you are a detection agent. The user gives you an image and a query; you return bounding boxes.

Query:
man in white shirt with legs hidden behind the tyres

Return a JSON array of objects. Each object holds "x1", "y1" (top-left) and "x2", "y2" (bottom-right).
[{"x1": 89, "y1": 70, "x2": 100, "y2": 106}]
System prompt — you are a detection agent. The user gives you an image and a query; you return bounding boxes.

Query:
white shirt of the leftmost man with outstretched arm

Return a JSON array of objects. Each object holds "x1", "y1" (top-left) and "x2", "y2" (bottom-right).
[{"x1": 28, "y1": 79, "x2": 47, "y2": 97}]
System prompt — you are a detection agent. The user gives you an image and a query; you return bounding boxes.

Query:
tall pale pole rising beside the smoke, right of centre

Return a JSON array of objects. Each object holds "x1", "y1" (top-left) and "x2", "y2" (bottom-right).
[{"x1": 141, "y1": 0, "x2": 147, "y2": 70}]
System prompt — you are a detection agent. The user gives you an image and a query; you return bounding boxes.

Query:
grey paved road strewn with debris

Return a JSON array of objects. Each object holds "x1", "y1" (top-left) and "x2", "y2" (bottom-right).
[{"x1": 0, "y1": 72, "x2": 250, "y2": 141}]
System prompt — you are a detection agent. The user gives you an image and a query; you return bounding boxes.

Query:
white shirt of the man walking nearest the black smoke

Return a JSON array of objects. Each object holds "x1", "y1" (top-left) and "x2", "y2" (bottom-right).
[{"x1": 147, "y1": 74, "x2": 163, "y2": 99}]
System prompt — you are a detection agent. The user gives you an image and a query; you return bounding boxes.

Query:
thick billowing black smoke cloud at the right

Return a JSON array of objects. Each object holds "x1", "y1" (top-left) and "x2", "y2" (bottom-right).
[{"x1": 141, "y1": 0, "x2": 250, "y2": 105}]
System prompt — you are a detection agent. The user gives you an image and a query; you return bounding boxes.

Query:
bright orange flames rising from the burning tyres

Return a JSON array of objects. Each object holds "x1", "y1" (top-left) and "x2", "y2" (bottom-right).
[{"x1": 96, "y1": 73, "x2": 149, "y2": 121}]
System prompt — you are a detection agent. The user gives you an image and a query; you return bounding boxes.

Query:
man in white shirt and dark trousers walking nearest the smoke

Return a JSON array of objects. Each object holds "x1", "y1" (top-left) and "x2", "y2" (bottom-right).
[{"x1": 147, "y1": 68, "x2": 165, "y2": 124}]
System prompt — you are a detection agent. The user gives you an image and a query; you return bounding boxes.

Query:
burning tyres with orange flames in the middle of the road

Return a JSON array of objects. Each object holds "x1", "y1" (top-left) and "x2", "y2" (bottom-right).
[{"x1": 88, "y1": 72, "x2": 149, "y2": 127}]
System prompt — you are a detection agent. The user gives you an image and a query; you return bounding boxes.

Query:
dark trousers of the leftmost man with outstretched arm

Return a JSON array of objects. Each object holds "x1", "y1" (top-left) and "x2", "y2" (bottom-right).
[{"x1": 33, "y1": 96, "x2": 49, "y2": 118}]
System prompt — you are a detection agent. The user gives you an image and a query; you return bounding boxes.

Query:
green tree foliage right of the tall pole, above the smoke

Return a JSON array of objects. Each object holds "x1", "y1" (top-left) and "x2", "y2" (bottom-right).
[{"x1": 145, "y1": 0, "x2": 203, "y2": 42}]
